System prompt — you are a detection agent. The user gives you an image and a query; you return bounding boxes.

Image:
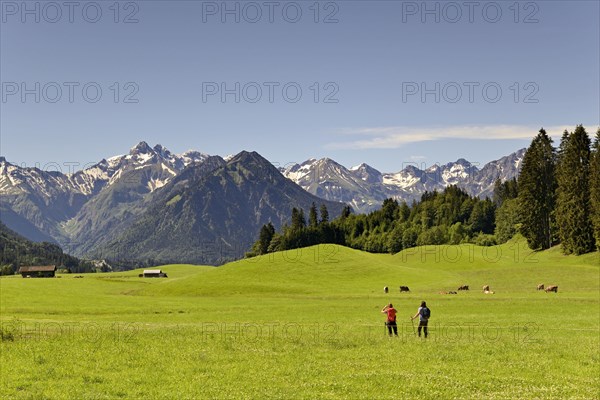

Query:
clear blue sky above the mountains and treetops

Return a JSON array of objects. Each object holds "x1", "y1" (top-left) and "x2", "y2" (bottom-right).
[{"x1": 0, "y1": 1, "x2": 600, "y2": 172}]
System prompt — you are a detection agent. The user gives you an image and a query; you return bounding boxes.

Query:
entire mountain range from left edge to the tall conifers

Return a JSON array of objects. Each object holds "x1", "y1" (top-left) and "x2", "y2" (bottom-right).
[{"x1": 0, "y1": 142, "x2": 524, "y2": 264}]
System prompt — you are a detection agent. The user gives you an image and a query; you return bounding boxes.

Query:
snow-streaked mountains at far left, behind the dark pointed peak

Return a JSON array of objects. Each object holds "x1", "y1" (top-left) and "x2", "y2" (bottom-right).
[{"x1": 0, "y1": 142, "x2": 208, "y2": 248}]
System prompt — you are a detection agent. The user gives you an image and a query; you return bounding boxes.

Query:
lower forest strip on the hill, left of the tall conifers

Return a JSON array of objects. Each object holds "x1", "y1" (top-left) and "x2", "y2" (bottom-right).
[{"x1": 247, "y1": 186, "x2": 504, "y2": 257}]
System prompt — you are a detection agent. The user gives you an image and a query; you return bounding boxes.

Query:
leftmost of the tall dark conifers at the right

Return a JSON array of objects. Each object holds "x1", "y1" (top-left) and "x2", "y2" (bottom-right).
[{"x1": 518, "y1": 128, "x2": 556, "y2": 250}]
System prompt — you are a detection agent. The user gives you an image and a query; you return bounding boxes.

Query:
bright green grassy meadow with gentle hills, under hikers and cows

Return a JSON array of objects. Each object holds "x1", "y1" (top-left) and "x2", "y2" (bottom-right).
[{"x1": 0, "y1": 239, "x2": 600, "y2": 399}]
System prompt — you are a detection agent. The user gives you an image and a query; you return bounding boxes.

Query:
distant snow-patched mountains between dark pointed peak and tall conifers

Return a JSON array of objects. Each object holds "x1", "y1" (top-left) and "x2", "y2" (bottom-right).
[{"x1": 281, "y1": 149, "x2": 526, "y2": 213}]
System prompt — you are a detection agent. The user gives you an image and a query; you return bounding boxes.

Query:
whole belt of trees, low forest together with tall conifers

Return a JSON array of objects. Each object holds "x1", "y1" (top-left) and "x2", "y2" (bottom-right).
[{"x1": 247, "y1": 125, "x2": 600, "y2": 256}]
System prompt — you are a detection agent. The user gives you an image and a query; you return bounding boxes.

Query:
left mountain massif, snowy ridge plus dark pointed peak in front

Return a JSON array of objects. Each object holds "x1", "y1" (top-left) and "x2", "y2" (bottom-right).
[{"x1": 0, "y1": 142, "x2": 344, "y2": 264}]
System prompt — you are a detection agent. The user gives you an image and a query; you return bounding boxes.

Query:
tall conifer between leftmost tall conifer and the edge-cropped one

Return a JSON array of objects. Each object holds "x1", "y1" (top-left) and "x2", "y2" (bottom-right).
[{"x1": 556, "y1": 125, "x2": 595, "y2": 254}]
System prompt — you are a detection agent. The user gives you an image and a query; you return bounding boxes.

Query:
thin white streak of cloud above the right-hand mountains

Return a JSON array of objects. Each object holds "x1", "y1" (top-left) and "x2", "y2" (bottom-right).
[{"x1": 327, "y1": 125, "x2": 596, "y2": 149}]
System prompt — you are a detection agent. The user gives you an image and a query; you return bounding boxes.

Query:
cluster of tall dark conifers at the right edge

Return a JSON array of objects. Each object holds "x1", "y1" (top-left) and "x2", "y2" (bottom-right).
[{"x1": 518, "y1": 125, "x2": 600, "y2": 254}]
